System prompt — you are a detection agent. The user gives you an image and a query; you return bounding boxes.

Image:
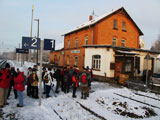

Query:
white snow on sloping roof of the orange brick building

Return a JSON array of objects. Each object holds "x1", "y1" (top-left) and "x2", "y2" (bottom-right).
[{"x1": 64, "y1": 7, "x2": 123, "y2": 35}]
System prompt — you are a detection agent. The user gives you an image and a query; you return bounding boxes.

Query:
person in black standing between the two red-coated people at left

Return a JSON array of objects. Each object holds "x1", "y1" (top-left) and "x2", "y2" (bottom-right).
[{"x1": 8, "y1": 67, "x2": 17, "y2": 99}]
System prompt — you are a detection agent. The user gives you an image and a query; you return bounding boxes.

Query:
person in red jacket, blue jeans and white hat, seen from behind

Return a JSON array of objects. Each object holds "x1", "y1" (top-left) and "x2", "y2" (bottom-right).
[{"x1": 14, "y1": 68, "x2": 25, "y2": 107}]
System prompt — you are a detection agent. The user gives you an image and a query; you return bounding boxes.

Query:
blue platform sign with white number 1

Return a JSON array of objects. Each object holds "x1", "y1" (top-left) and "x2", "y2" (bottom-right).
[{"x1": 44, "y1": 39, "x2": 55, "y2": 51}]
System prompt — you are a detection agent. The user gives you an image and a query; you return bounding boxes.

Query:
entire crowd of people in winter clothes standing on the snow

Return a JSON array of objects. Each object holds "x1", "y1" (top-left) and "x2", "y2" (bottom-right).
[{"x1": 0, "y1": 63, "x2": 93, "y2": 108}]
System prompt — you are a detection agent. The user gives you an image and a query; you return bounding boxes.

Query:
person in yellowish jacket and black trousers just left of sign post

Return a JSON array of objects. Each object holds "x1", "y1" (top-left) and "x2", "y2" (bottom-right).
[{"x1": 31, "y1": 69, "x2": 38, "y2": 99}]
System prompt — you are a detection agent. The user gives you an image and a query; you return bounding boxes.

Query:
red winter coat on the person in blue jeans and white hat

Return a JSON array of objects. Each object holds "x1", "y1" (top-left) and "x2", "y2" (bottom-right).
[{"x1": 14, "y1": 72, "x2": 25, "y2": 91}]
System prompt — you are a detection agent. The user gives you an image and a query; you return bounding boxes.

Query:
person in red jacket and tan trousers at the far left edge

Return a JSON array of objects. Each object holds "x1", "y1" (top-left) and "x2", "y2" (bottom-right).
[{"x1": 0, "y1": 63, "x2": 11, "y2": 108}]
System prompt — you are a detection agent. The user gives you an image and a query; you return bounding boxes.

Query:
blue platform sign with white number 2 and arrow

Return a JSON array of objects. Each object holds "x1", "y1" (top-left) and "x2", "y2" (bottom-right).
[{"x1": 22, "y1": 37, "x2": 40, "y2": 50}]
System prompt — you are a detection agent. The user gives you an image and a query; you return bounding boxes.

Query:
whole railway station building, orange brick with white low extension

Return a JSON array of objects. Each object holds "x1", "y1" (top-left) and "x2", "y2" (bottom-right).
[{"x1": 50, "y1": 7, "x2": 159, "y2": 79}]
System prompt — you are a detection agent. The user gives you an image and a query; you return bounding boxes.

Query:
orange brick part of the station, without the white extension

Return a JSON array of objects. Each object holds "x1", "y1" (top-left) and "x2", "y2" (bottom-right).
[{"x1": 50, "y1": 7, "x2": 143, "y2": 69}]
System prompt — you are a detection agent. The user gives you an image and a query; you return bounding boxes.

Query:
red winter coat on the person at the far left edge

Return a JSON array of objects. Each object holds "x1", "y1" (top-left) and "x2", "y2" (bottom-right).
[{"x1": 0, "y1": 69, "x2": 11, "y2": 88}]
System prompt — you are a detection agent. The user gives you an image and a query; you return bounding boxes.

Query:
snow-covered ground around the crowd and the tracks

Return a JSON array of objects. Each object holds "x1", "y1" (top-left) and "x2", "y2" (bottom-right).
[{"x1": 0, "y1": 61, "x2": 160, "y2": 120}]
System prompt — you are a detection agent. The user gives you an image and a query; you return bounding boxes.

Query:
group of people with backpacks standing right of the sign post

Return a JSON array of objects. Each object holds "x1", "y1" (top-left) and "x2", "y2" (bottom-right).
[{"x1": 42, "y1": 67, "x2": 93, "y2": 99}]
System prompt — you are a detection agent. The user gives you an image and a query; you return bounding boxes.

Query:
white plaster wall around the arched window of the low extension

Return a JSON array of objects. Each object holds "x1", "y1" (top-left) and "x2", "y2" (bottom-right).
[{"x1": 85, "y1": 48, "x2": 114, "y2": 77}]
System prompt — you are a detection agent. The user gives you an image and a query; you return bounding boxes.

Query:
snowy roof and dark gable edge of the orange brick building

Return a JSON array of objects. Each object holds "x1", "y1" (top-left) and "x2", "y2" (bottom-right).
[{"x1": 64, "y1": 7, "x2": 143, "y2": 35}]
